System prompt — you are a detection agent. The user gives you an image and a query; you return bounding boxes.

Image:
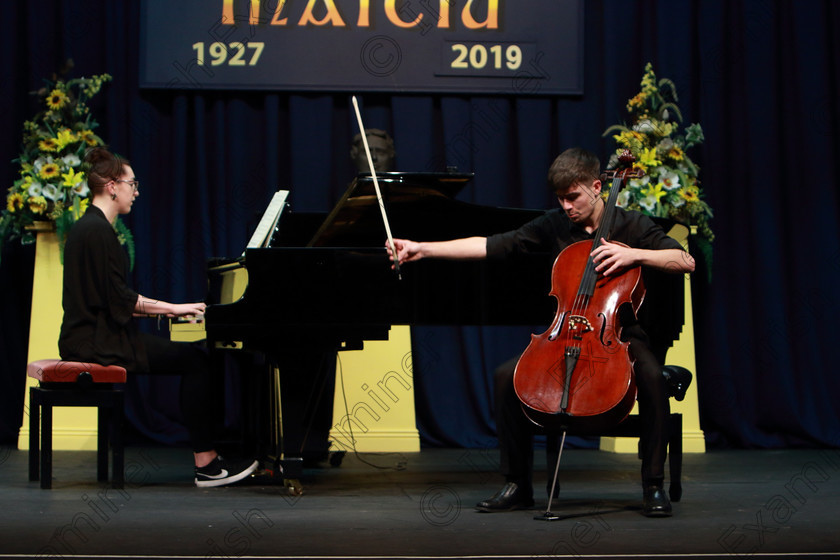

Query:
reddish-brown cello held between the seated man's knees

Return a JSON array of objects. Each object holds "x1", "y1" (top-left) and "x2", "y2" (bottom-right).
[{"x1": 513, "y1": 150, "x2": 645, "y2": 519}]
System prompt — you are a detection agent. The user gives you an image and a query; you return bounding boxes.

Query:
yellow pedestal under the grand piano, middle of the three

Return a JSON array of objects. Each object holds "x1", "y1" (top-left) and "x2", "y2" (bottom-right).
[{"x1": 330, "y1": 326, "x2": 420, "y2": 452}]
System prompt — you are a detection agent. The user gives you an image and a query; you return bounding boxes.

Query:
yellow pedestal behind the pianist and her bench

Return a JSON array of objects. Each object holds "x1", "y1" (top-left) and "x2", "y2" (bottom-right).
[{"x1": 18, "y1": 231, "x2": 97, "y2": 450}]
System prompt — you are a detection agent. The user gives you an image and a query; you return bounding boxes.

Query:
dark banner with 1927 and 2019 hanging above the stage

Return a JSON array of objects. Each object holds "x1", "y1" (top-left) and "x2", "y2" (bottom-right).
[{"x1": 140, "y1": 0, "x2": 583, "y2": 95}]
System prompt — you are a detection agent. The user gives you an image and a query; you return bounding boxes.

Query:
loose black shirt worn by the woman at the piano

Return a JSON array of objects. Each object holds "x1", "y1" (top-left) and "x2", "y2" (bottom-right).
[{"x1": 58, "y1": 205, "x2": 148, "y2": 372}]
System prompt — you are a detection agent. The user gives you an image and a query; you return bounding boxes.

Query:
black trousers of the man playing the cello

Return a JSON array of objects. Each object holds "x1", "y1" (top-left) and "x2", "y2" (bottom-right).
[{"x1": 494, "y1": 338, "x2": 670, "y2": 490}]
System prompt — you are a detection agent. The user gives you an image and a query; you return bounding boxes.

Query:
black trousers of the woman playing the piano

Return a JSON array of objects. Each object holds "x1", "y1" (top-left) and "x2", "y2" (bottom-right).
[{"x1": 138, "y1": 333, "x2": 215, "y2": 453}]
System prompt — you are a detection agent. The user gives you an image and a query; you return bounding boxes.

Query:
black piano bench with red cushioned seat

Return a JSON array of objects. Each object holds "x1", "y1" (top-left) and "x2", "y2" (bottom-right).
[{"x1": 26, "y1": 360, "x2": 126, "y2": 489}]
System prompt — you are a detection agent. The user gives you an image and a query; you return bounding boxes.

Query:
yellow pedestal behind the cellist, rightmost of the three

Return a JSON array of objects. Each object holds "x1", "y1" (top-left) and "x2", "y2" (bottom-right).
[{"x1": 601, "y1": 225, "x2": 706, "y2": 453}]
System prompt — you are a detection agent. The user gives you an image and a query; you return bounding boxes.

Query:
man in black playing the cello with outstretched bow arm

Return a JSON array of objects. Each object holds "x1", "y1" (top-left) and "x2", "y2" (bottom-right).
[{"x1": 391, "y1": 148, "x2": 695, "y2": 517}]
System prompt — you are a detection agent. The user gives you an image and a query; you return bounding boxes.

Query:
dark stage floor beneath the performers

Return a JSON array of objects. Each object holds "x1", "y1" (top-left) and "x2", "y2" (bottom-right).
[{"x1": 0, "y1": 447, "x2": 840, "y2": 559}]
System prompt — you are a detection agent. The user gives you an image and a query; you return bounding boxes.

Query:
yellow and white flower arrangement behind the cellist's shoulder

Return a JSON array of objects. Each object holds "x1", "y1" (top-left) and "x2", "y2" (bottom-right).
[{"x1": 604, "y1": 63, "x2": 714, "y2": 266}]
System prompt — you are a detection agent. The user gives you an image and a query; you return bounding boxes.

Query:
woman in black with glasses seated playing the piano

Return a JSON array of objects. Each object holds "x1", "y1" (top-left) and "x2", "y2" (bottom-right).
[{"x1": 58, "y1": 148, "x2": 257, "y2": 487}]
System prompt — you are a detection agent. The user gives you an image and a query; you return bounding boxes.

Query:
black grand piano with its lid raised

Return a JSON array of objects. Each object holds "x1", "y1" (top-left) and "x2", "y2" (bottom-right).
[{"x1": 205, "y1": 173, "x2": 555, "y2": 484}]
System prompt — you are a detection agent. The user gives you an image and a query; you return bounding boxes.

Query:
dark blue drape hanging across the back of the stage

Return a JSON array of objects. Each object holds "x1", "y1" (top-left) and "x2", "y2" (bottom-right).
[{"x1": 0, "y1": 0, "x2": 840, "y2": 447}]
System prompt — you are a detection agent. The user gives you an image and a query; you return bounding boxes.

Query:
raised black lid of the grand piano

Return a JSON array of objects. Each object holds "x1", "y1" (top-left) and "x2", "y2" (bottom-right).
[{"x1": 307, "y1": 172, "x2": 542, "y2": 247}]
